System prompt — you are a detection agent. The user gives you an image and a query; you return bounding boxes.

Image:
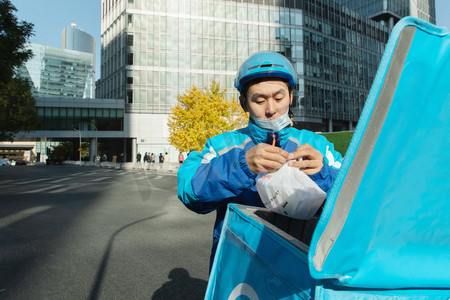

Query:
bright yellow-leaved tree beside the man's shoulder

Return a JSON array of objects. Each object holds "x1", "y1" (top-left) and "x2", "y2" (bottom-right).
[{"x1": 168, "y1": 81, "x2": 248, "y2": 152}]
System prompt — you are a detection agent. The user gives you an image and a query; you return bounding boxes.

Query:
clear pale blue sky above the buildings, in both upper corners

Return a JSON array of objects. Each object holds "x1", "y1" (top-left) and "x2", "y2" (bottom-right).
[{"x1": 11, "y1": 0, "x2": 450, "y2": 79}]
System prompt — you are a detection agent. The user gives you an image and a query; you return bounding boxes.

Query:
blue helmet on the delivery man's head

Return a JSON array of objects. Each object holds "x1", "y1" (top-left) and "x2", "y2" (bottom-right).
[{"x1": 234, "y1": 51, "x2": 297, "y2": 93}]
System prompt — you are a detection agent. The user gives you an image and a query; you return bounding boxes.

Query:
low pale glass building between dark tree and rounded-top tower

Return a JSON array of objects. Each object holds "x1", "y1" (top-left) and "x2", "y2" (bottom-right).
[{"x1": 19, "y1": 44, "x2": 94, "y2": 98}]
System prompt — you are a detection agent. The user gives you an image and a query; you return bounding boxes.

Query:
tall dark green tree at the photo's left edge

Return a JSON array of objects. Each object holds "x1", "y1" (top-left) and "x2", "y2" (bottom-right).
[{"x1": 0, "y1": 0, "x2": 37, "y2": 141}]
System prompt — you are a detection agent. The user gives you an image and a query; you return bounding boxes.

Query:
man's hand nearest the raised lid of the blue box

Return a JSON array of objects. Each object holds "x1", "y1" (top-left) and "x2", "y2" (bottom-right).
[{"x1": 288, "y1": 144, "x2": 323, "y2": 175}]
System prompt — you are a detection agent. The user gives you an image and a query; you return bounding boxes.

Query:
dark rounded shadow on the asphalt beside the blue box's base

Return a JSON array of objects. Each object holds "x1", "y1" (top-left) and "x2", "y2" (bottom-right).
[{"x1": 152, "y1": 268, "x2": 208, "y2": 300}]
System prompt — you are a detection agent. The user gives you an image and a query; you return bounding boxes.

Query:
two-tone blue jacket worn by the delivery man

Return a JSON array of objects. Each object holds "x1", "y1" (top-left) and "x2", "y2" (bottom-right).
[{"x1": 178, "y1": 122, "x2": 342, "y2": 263}]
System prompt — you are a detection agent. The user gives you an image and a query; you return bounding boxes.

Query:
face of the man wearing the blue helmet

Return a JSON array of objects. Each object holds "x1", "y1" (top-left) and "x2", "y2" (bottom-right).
[{"x1": 246, "y1": 79, "x2": 293, "y2": 120}]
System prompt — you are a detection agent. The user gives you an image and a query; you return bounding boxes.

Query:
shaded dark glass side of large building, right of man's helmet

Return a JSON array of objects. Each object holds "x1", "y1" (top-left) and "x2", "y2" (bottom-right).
[{"x1": 294, "y1": 1, "x2": 388, "y2": 131}]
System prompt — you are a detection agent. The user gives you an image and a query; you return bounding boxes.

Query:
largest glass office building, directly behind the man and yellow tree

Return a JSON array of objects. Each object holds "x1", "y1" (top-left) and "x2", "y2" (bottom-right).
[{"x1": 96, "y1": 0, "x2": 432, "y2": 131}]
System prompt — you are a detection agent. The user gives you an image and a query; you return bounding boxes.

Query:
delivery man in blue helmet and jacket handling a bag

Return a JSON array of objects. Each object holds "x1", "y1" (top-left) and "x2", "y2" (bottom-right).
[{"x1": 178, "y1": 52, "x2": 342, "y2": 264}]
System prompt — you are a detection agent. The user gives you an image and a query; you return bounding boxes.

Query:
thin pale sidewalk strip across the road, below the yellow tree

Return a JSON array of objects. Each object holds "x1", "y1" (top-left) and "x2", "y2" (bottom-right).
[{"x1": 63, "y1": 160, "x2": 180, "y2": 175}]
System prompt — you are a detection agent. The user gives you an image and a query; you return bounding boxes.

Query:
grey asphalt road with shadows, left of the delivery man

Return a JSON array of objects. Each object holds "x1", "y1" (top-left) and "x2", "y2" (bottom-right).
[{"x1": 0, "y1": 166, "x2": 214, "y2": 299}]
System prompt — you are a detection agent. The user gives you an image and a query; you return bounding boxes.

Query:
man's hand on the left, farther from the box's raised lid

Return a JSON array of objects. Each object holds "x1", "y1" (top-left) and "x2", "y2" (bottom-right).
[{"x1": 245, "y1": 144, "x2": 289, "y2": 174}]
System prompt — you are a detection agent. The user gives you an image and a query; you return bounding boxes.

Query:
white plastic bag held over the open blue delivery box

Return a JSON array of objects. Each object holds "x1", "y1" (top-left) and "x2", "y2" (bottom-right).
[{"x1": 256, "y1": 163, "x2": 327, "y2": 220}]
